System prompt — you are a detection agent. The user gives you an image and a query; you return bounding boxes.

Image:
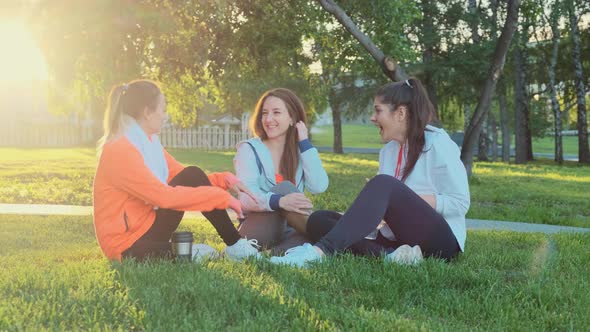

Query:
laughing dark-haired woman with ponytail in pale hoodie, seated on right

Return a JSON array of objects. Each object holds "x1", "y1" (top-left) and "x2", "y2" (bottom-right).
[{"x1": 271, "y1": 79, "x2": 470, "y2": 266}]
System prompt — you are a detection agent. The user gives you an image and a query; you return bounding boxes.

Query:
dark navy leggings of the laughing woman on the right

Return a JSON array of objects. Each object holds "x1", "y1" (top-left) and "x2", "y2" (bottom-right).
[{"x1": 307, "y1": 175, "x2": 461, "y2": 260}]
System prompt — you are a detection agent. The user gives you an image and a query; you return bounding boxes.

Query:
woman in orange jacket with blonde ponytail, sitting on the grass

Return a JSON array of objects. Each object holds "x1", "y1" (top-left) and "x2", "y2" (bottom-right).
[{"x1": 93, "y1": 80, "x2": 259, "y2": 260}]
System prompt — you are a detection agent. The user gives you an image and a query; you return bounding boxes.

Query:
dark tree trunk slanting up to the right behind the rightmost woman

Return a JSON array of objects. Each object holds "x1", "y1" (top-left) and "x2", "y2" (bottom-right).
[{"x1": 461, "y1": 0, "x2": 520, "y2": 175}]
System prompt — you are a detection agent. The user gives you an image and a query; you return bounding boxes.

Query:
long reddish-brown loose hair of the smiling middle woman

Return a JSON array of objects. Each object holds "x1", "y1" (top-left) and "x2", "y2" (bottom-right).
[{"x1": 250, "y1": 88, "x2": 307, "y2": 183}]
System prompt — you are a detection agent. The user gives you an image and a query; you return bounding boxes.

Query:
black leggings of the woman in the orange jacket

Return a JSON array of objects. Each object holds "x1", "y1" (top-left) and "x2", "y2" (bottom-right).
[{"x1": 123, "y1": 166, "x2": 240, "y2": 260}]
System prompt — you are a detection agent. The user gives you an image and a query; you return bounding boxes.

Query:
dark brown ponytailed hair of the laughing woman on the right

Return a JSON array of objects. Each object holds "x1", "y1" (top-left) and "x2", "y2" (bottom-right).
[{"x1": 375, "y1": 78, "x2": 436, "y2": 182}]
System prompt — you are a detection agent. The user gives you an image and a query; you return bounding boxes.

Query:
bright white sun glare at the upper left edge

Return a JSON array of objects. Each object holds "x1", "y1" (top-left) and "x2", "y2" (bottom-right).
[{"x1": 0, "y1": 21, "x2": 47, "y2": 82}]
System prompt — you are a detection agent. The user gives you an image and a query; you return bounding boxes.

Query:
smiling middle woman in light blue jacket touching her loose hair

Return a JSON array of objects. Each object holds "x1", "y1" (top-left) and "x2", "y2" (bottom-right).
[{"x1": 234, "y1": 88, "x2": 328, "y2": 252}]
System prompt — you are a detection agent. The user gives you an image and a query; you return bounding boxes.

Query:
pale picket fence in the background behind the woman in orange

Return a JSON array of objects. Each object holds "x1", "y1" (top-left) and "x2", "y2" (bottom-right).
[{"x1": 0, "y1": 124, "x2": 248, "y2": 150}]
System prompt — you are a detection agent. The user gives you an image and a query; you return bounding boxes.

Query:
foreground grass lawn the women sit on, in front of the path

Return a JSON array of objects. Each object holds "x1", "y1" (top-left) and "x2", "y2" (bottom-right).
[{"x1": 0, "y1": 216, "x2": 590, "y2": 331}]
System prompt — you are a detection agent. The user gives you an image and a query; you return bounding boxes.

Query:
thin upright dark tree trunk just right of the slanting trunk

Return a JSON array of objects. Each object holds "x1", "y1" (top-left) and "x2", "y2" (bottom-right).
[{"x1": 514, "y1": 31, "x2": 528, "y2": 164}]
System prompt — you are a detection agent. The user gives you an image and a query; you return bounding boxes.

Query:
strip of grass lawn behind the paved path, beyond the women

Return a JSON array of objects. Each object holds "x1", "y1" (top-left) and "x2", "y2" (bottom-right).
[{"x1": 0, "y1": 149, "x2": 590, "y2": 227}]
